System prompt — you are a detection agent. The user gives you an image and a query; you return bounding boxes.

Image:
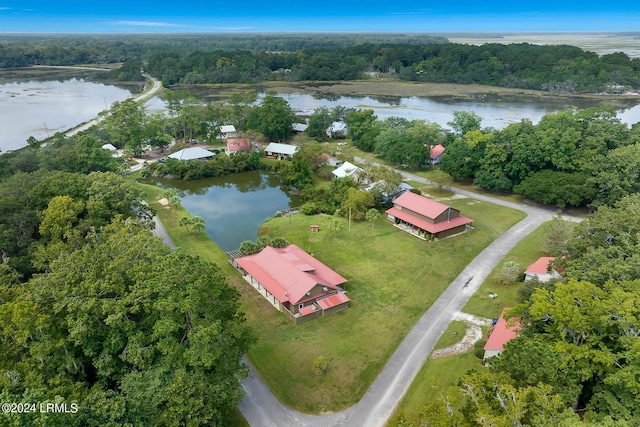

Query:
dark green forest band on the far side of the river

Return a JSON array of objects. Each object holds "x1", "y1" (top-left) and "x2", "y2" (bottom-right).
[{"x1": 148, "y1": 43, "x2": 640, "y2": 93}]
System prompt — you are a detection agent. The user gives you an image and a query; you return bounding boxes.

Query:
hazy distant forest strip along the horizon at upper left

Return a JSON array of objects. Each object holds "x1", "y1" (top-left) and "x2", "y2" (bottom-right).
[{"x1": 0, "y1": 33, "x2": 447, "y2": 68}]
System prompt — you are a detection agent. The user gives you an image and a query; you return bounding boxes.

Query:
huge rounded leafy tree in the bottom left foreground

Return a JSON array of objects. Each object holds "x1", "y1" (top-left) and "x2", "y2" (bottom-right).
[{"x1": 0, "y1": 221, "x2": 252, "y2": 426}]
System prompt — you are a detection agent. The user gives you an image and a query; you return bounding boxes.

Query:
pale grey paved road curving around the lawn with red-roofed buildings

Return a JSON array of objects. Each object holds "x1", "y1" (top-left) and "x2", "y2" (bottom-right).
[{"x1": 239, "y1": 166, "x2": 578, "y2": 427}]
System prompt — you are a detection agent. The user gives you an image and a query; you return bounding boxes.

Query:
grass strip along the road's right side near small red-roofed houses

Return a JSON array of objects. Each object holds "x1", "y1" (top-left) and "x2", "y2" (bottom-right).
[{"x1": 395, "y1": 222, "x2": 576, "y2": 419}]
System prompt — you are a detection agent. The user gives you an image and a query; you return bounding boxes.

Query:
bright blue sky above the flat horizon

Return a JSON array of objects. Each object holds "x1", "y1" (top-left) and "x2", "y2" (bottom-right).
[{"x1": 0, "y1": 0, "x2": 640, "y2": 33}]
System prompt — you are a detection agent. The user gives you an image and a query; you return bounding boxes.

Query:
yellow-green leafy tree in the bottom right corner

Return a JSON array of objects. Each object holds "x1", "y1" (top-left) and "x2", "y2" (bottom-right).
[{"x1": 524, "y1": 279, "x2": 640, "y2": 424}]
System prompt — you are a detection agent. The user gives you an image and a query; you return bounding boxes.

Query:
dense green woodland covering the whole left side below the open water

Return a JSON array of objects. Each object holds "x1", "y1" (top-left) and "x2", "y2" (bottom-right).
[{"x1": 0, "y1": 122, "x2": 253, "y2": 427}]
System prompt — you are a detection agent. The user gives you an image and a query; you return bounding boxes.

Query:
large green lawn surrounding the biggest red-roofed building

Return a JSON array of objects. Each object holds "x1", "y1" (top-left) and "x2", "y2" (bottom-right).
[{"x1": 131, "y1": 176, "x2": 524, "y2": 413}]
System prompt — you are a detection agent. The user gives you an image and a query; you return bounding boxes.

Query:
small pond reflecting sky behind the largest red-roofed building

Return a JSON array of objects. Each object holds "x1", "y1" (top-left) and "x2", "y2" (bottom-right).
[{"x1": 152, "y1": 171, "x2": 299, "y2": 251}]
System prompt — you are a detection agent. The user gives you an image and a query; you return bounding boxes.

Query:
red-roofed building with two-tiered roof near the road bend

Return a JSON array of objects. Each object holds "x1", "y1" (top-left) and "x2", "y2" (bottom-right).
[{"x1": 386, "y1": 191, "x2": 473, "y2": 239}]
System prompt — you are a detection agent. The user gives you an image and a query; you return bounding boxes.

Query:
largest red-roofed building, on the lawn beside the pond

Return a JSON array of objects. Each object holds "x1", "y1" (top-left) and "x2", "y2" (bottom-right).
[{"x1": 235, "y1": 245, "x2": 349, "y2": 323}]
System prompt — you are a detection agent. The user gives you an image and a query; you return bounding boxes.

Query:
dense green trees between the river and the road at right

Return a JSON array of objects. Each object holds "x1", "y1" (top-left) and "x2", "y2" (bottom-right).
[{"x1": 307, "y1": 107, "x2": 640, "y2": 209}]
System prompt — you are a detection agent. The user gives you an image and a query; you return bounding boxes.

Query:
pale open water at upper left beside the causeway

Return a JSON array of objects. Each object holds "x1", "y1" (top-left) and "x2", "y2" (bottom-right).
[{"x1": 0, "y1": 77, "x2": 139, "y2": 152}]
